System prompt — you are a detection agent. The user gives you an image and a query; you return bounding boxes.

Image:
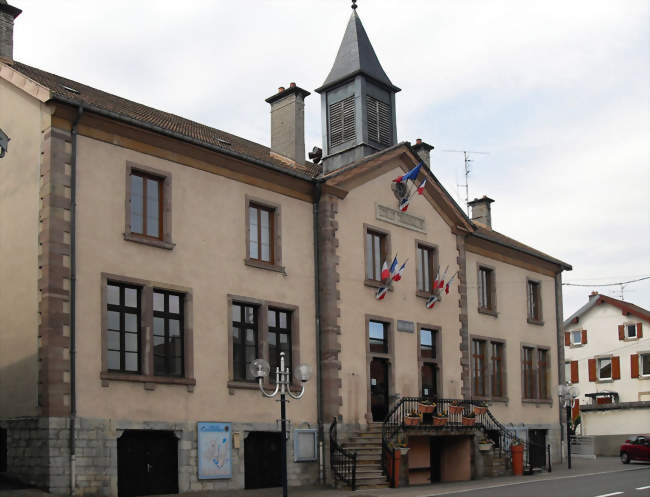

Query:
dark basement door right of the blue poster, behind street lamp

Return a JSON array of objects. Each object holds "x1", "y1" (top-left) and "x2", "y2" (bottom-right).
[{"x1": 244, "y1": 431, "x2": 282, "y2": 488}]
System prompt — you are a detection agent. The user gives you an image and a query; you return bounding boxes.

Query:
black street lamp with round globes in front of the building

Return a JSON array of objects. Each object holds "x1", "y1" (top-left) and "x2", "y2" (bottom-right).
[{"x1": 248, "y1": 352, "x2": 311, "y2": 497}]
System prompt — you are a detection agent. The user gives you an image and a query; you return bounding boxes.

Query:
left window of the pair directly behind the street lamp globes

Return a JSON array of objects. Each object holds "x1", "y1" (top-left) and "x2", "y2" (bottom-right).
[{"x1": 231, "y1": 302, "x2": 259, "y2": 381}]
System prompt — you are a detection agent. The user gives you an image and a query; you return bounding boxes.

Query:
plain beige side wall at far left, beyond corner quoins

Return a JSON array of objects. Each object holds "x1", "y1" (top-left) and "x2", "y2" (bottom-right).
[{"x1": 0, "y1": 78, "x2": 50, "y2": 417}]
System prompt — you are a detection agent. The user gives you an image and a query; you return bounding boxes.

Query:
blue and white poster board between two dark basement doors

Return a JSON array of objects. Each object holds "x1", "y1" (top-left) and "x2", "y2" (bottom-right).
[{"x1": 196, "y1": 423, "x2": 232, "y2": 480}]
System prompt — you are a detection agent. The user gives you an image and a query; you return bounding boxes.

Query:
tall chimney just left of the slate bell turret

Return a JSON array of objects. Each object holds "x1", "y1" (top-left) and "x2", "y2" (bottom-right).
[{"x1": 266, "y1": 82, "x2": 309, "y2": 164}]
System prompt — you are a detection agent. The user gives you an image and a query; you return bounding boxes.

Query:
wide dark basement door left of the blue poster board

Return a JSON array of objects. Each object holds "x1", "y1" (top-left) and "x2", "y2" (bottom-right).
[{"x1": 117, "y1": 430, "x2": 178, "y2": 497}]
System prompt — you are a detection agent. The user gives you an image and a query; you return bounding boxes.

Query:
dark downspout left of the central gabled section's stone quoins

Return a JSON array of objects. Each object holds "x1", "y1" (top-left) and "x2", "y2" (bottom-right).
[{"x1": 313, "y1": 182, "x2": 325, "y2": 485}]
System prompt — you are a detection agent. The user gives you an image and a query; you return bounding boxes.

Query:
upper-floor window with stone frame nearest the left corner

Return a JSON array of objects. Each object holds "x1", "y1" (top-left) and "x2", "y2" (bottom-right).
[{"x1": 124, "y1": 162, "x2": 174, "y2": 249}]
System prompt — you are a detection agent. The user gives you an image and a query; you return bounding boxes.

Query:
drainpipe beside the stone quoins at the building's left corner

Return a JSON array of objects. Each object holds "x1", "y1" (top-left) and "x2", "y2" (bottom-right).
[{"x1": 69, "y1": 104, "x2": 84, "y2": 495}]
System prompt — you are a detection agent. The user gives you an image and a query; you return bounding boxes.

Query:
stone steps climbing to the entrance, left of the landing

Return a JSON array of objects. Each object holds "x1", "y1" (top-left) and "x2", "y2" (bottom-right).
[{"x1": 341, "y1": 423, "x2": 388, "y2": 489}]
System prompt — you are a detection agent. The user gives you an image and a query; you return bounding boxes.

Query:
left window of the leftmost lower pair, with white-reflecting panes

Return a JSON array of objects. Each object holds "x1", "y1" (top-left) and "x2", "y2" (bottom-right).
[{"x1": 106, "y1": 282, "x2": 140, "y2": 373}]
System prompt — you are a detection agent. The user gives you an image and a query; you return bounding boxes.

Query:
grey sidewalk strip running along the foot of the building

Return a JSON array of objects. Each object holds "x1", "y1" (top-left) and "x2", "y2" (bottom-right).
[{"x1": 0, "y1": 457, "x2": 650, "y2": 497}]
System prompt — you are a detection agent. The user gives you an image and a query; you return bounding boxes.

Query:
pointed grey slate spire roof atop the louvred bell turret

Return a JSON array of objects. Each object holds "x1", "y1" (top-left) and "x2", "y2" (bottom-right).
[{"x1": 316, "y1": 10, "x2": 400, "y2": 93}]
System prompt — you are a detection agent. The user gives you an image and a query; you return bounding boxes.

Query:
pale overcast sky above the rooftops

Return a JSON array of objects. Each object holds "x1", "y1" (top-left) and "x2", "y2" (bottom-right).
[{"x1": 9, "y1": 0, "x2": 650, "y2": 317}]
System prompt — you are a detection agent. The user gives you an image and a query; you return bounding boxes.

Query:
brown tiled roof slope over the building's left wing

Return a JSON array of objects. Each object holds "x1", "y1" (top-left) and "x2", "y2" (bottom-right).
[{"x1": 12, "y1": 62, "x2": 318, "y2": 177}]
